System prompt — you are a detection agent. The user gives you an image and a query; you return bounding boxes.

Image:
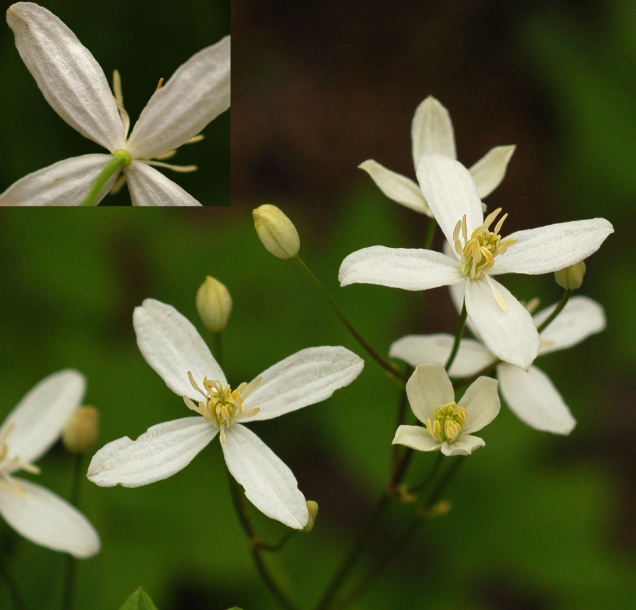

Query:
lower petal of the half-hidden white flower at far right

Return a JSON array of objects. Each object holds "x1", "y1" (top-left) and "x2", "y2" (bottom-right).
[{"x1": 497, "y1": 364, "x2": 576, "y2": 434}]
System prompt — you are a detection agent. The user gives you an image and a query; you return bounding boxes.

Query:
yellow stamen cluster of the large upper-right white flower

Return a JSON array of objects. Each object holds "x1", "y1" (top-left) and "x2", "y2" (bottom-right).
[{"x1": 453, "y1": 208, "x2": 517, "y2": 280}]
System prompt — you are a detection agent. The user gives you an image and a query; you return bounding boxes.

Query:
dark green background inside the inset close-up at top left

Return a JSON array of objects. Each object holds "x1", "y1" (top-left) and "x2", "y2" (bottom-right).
[{"x1": 0, "y1": 0, "x2": 230, "y2": 206}]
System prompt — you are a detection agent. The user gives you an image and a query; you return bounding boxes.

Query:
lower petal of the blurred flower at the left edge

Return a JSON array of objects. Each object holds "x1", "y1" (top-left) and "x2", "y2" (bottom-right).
[{"x1": 0, "y1": 479, "x2": 100, "y2": 559}]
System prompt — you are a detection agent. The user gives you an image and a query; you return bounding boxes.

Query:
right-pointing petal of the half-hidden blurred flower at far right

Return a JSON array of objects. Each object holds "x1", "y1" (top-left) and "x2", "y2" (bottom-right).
[{"x1": 534, "y1": 296, "x2": 605, "y2": 354}]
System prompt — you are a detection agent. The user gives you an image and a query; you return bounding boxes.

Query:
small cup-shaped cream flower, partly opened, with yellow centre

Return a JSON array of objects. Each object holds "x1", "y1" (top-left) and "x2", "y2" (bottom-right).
[{"x1": 393, "y1": 362, "x2": 500, "y2": 455}]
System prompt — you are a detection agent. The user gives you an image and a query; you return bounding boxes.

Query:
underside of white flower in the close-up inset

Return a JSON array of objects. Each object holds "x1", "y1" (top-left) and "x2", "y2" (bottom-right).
[{"x1": 0, "y1": 2, "x2": 230, "y2": 206}]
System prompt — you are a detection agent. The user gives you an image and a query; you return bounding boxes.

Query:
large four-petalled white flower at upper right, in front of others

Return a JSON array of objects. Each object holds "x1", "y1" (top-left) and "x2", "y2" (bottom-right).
[{"x1": 339, "y1": 155, "x2": 614, "y2": 370}]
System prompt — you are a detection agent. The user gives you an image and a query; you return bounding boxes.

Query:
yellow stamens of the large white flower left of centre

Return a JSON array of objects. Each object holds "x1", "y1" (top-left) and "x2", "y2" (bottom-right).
[{"x1": 183, "y1": 371, "x2": 261, "y2": 443}]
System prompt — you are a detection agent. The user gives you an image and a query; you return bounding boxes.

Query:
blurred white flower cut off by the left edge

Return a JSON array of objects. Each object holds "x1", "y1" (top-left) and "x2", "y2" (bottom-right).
[{"x1": 0, "y1": 370, "x2": 100, "y2": 558}]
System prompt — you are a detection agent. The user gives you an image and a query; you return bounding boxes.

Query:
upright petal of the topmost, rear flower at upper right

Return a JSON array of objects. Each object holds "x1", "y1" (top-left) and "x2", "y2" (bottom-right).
[{"x1": 411, "y1": 95, "x2": 457, "y2": 162}]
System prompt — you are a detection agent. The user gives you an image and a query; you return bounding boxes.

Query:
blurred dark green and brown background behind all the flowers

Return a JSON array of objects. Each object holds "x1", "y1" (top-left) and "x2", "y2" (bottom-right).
[{"x1": 0, "y1": 0, "x2": 636, "y2": 610}]
